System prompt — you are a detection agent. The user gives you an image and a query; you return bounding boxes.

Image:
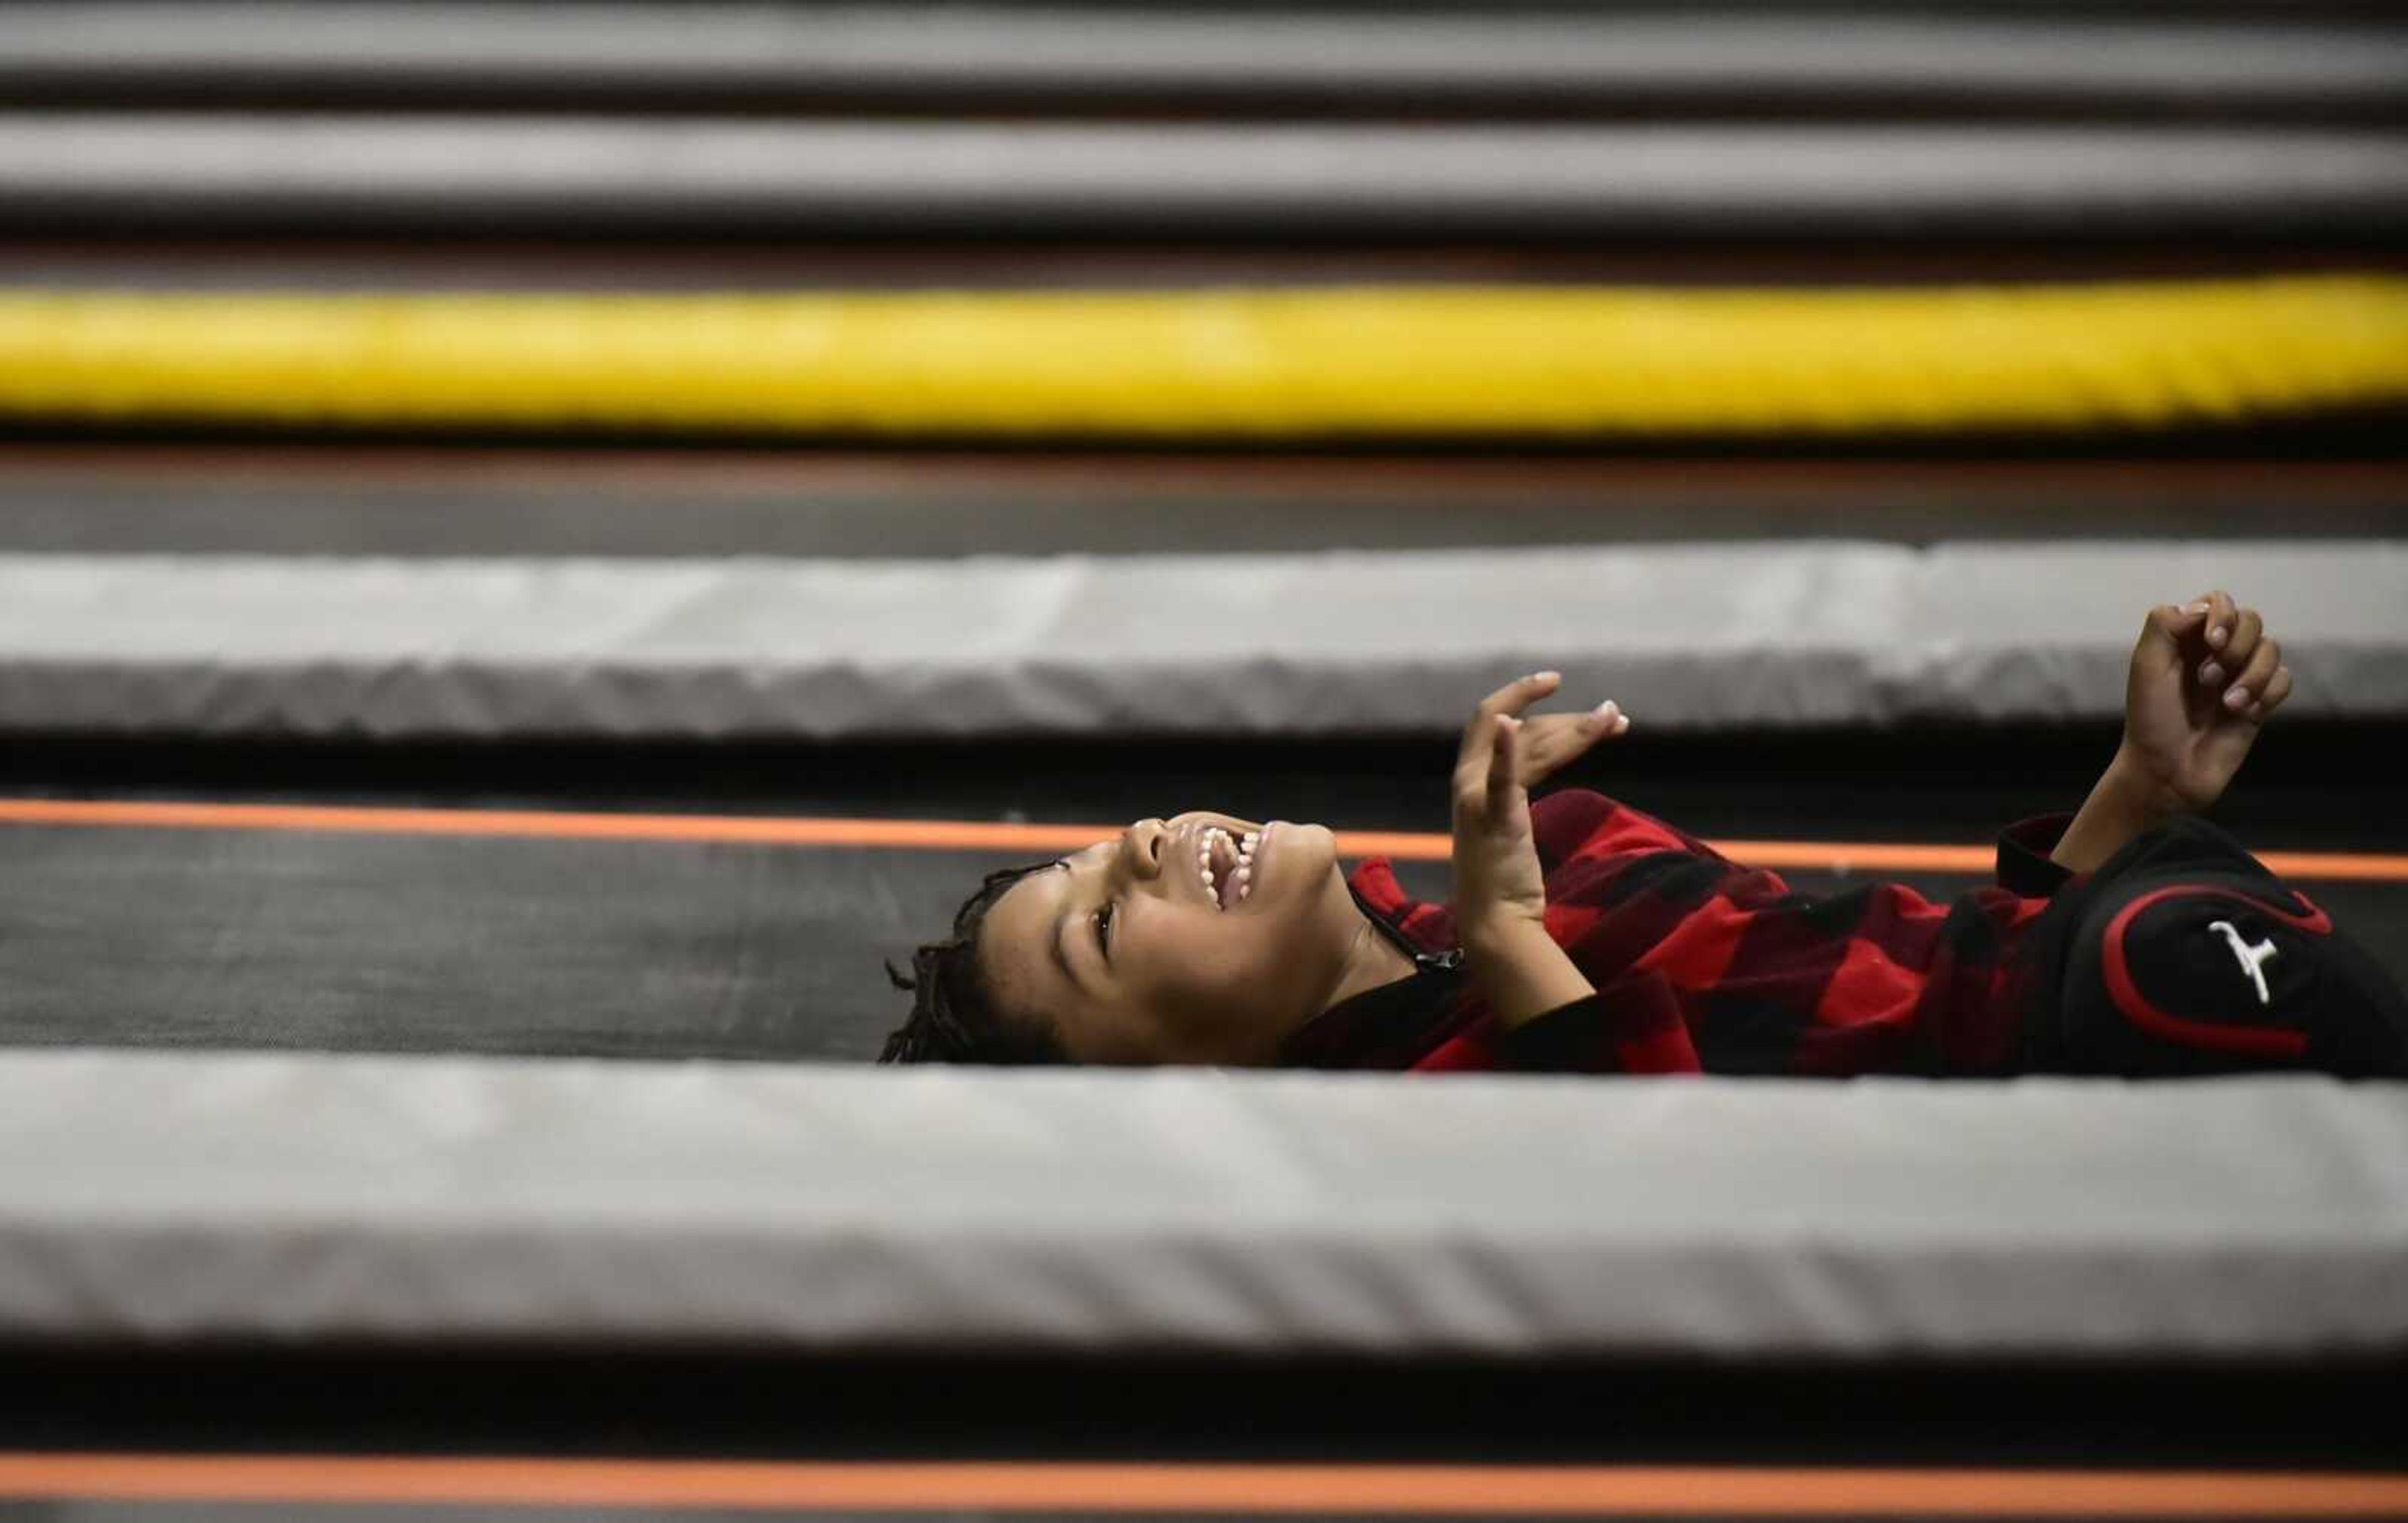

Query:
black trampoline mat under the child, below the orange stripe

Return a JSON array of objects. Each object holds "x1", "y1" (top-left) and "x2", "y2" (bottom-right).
[{"x1": 0, "y1": 803, "x2": 2408, "y2": 1061}]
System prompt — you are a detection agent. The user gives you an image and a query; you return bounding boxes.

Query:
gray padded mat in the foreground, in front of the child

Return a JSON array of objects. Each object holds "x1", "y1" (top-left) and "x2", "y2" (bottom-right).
[{"x1": 0, "y1": 1051, "x2": 2408, "y2": 1357}]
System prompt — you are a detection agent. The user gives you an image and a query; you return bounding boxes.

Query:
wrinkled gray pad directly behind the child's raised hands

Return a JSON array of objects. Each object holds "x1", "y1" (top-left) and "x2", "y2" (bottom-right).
[{"x1": 0, "y1": 541, "x2": 2408, "y2": 739}]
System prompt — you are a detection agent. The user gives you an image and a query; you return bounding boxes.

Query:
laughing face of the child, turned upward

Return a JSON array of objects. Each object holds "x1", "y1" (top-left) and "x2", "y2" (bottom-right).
[{"x1": 980, "y1": 813, "x2": 1373, "y2": 1063}]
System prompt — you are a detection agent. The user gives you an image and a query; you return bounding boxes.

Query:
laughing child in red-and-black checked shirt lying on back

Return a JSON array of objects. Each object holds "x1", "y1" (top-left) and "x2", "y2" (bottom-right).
[{"x1": 881, "y1": 592, "x2": 2408, "y2": 1078}]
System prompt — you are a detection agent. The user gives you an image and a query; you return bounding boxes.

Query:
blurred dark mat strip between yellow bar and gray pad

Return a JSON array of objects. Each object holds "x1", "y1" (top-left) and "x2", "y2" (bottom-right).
[{"x1": 19, "y1": 443, "x2": 2408, "y2": 558}]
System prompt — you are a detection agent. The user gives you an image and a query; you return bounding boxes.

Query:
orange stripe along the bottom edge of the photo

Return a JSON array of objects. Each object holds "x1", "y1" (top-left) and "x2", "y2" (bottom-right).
[{"x1": 0, "y1": 1453, "x2": 2408, "y2": 1518}]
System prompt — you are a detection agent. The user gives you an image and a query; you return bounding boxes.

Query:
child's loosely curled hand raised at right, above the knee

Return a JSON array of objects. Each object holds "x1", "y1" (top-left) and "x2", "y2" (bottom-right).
[{"x1": 2119, "y1": 592, "x2": 2290, "y2": 811}]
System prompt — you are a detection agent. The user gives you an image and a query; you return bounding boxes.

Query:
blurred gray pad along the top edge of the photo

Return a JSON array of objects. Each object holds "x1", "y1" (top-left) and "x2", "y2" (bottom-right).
[{"x1": 0, "y1": 0, "x2": 2408, "y2": 113}]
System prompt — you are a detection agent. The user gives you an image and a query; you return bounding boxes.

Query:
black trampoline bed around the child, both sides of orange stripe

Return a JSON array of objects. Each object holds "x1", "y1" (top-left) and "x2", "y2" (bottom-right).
[{"x1": 0, "y1": 722, "x2": 2408, "y2": 1061}]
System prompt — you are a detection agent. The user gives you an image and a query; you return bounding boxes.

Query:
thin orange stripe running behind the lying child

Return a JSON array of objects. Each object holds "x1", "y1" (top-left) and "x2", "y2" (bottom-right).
[{"x1": 0, "y1": 799, "x2": 2408, "y2": 883}]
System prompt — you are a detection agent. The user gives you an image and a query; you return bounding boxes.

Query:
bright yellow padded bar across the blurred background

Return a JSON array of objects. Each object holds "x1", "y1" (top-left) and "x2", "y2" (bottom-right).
[{"x1": 0, "y1": 274, "x2": 2408, "y2": 438}]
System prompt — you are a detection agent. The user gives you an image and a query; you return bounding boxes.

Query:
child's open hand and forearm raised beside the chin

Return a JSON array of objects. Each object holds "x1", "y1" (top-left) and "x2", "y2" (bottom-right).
[{"x1": 1454, "y1": 672, "x2": 1630, "y2": 939}]
